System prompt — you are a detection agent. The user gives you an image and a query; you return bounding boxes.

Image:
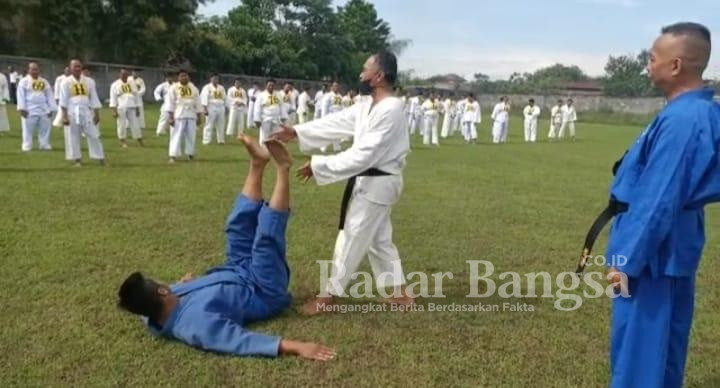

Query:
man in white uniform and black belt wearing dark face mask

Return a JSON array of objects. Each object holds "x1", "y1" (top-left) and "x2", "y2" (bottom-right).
[{"x1": 275, "y1": 51, "x2": 414, "y2": 315}]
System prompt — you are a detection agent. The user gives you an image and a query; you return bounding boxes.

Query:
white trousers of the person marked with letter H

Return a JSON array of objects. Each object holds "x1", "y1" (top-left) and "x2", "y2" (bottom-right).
[{"x1": 65, "y1": 106, "x2": 105, "y2": 160}]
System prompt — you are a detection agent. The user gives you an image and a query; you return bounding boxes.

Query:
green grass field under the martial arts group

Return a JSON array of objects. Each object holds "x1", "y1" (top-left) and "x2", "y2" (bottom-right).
[{"x1": 0, "y1": 107, "x2": 720, "y2": 387}]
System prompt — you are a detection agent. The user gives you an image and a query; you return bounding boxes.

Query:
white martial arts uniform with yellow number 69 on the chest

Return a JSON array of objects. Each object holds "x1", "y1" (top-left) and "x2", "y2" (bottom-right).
[{"x1": 17, "y1": 75, "x2": 57, "y2": 151}]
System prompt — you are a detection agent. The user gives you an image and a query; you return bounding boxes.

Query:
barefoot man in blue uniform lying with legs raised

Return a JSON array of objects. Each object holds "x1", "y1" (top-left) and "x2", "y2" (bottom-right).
[{"x1": 118, "y1": 136, "x2": 335, "y2": 361}]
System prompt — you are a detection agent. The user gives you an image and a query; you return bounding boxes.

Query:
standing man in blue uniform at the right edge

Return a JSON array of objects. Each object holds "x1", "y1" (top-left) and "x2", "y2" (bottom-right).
[{"x1": 606, "y1": 23, "x2": 720, "y2": 388}]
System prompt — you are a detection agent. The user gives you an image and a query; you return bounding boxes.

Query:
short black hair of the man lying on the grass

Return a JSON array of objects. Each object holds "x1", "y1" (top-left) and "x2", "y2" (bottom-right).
[{"x1": 118, "y1": 272, "x2": 163, "y2": 322}]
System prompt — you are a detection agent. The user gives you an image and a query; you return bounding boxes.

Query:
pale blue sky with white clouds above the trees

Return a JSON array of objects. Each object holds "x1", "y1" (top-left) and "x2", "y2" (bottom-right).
[{"x1": 199, "y1": 0, "x2": 720, "y2": 79}]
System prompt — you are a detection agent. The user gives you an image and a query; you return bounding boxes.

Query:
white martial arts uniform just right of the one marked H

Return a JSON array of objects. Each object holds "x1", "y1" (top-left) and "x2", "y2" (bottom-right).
[{"x1": 110, "y1": 78, "x2": 142, "y2": 140}]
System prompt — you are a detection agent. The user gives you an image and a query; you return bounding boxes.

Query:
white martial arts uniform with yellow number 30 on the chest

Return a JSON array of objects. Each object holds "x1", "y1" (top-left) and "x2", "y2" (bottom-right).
[{"x1": 168, "y1": 81, "x2": 203, "y2": 158}]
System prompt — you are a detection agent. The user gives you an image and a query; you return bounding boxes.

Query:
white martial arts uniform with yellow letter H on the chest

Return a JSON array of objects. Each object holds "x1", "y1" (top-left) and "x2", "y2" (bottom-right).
[{"x1": 59, "y1": 75, "x2": 105, "y2": 160}]
